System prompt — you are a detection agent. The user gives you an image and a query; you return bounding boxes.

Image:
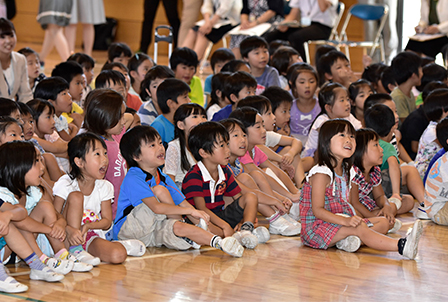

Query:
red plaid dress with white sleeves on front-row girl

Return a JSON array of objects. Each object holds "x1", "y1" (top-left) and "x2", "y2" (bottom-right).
[{"x1": 299, "y1": 165, "x2": 355, "y2": 249}]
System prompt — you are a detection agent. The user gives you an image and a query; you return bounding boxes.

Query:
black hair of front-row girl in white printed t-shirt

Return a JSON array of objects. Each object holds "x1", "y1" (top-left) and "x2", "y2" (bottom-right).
[{"x1": 67, "y1": 132, "x2": 107, "y2": 180}]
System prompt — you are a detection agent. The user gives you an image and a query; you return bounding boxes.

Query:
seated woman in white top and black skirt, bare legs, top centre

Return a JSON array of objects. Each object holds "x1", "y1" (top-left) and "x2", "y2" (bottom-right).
[{"x1": 183, "y1": 0, "x2": 243, "y2": 60}]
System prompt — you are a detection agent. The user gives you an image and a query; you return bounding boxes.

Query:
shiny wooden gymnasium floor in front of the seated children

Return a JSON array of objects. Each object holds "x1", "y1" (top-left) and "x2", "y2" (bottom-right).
[{"x1": 5, "y1": 45, "x2": 448, "y2": 302}]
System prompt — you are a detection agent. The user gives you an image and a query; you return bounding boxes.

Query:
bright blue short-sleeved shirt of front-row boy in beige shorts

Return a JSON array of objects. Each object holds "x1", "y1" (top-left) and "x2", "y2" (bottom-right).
[{"x1": 114, "y1": 167, "x2": 185, "y2": 240}]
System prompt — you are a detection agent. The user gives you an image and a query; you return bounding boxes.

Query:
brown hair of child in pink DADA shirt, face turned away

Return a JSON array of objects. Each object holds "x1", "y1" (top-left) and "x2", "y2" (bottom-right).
[{"x1": 83, "y1": 88, "x2": 123, "y2": 135}]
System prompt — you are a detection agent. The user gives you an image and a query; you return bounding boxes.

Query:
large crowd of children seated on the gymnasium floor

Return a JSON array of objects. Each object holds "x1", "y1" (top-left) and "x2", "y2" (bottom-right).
[{"x1": 0, "y1": 13, "x2": 448, "y2": 292}]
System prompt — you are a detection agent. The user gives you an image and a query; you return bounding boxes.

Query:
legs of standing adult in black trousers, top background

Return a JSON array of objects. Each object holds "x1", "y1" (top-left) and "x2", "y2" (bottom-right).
[{"x1": 140, "y1": 0, "x2": 181, "y2": 53}]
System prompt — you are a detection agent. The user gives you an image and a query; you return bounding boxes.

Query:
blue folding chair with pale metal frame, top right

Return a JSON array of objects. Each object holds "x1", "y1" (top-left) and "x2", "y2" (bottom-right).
[{"x1": 336, "y1": 4, "x2": 389, "y2": 62}]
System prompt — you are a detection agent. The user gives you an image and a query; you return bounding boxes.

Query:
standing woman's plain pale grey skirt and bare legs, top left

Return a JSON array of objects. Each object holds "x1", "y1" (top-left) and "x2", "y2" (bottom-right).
[{"x1": 65, "y1": 0, "x2": 106, "y2": 56}]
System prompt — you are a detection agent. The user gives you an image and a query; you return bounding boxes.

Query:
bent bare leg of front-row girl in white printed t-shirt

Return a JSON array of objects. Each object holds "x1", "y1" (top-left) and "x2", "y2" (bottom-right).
[{"x1": 87, "y1": 237, "x2": 128, "y2": 264}]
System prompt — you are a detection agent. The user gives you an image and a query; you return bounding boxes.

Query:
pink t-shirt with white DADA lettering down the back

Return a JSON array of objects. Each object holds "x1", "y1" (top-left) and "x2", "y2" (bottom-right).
[{"x1": 105, "y1": 128, "x2": 126, "y2": 219}]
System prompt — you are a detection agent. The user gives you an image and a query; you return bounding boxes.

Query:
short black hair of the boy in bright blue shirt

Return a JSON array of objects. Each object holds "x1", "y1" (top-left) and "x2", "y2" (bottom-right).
[{"x1": 120, "y1": 125, "x2": 160, "y2": 167}]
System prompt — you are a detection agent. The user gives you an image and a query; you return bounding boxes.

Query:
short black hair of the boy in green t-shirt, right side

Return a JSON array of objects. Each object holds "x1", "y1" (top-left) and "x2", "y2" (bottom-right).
[{"x1": 364, "y1": 104, "x2": 395, "y2": 137}]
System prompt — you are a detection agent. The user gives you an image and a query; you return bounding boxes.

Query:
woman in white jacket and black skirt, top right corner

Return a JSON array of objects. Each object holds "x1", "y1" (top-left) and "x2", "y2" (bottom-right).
[{"x1": 406, "y1": 0, "x2": 448, "y2": 58}]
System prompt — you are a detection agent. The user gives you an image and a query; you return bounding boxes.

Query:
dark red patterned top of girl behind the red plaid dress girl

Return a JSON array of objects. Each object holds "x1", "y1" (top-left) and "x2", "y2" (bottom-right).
[{"x1": 352, "y1": 166, "x2": 381, "y2": 211}]
